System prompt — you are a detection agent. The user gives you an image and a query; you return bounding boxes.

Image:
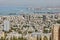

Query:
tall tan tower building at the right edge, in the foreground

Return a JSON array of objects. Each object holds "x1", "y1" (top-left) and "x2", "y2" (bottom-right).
[{"x1": 52, "y1": 24, "x2": 60, "y2": 40}]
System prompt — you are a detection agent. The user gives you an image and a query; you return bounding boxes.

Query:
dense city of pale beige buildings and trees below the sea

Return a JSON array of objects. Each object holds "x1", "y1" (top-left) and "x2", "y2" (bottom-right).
[{"x1": 0, "y1": 13, "x2": 60, "y2": 40}]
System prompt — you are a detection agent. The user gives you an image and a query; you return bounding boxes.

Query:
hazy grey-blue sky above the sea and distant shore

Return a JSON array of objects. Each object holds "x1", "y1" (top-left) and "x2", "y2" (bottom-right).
[{"x1": 0, "y1": 0, "x2": 60, "y2": 7}]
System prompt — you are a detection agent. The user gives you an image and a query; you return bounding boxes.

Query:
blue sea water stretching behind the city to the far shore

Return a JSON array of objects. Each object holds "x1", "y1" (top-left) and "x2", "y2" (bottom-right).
[{"x1": 0, "y1": 7, "x2": 60, "y2": 15}]
